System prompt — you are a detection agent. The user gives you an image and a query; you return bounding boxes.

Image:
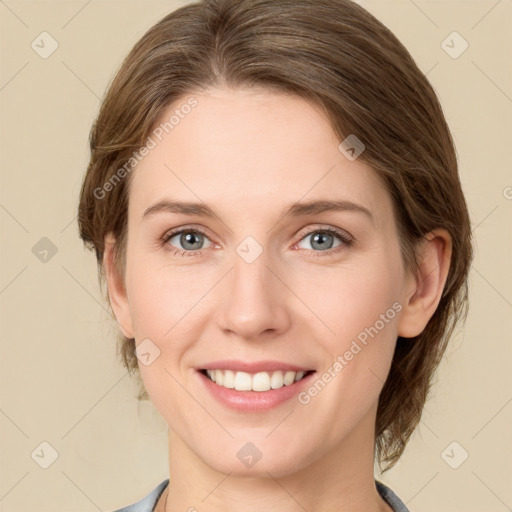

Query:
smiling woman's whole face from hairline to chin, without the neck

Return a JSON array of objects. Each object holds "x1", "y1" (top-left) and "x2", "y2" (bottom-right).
[{"x1": 111, "y1": 89, "x2": 418, "y2": 475}]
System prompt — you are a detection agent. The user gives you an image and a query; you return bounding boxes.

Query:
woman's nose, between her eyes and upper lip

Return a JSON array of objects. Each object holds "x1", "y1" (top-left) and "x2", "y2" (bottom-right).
[{"x1": 218, "y1": 251, "x2": 293, "y2": 340}]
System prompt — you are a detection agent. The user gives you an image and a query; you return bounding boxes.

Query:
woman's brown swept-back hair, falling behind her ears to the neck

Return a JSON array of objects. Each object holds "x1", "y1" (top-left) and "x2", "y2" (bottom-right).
[{"x1": 78, "y1": 0, "x2": 473, "y2": 471}]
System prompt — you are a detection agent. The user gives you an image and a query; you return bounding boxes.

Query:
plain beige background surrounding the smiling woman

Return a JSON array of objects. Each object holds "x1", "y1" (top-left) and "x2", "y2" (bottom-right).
[{"x1": 0, "y1": 0, "x2": 512, "y2": 512}]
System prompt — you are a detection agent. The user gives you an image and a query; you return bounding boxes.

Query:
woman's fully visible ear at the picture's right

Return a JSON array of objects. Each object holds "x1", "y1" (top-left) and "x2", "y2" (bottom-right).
[{"x1": 398, "y1": 229, "x2": 452, "y2": 338}]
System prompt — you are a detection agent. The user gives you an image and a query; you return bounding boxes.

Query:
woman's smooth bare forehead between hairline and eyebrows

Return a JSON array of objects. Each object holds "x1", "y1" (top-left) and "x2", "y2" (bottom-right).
[{"x1": 130, "y1": 89, "x2": 391, "y2": 226}]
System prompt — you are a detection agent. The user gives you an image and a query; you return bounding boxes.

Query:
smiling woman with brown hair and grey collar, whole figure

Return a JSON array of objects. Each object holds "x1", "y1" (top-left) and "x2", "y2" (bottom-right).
[{"x1": 79, "y1": 0, "x2": 472, "y2": 512}]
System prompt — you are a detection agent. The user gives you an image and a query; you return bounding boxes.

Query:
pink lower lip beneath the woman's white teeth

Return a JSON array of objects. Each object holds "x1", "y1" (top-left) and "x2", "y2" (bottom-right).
[{"x1": 197, "y1": 371, "x2": 316, "y2": 412}]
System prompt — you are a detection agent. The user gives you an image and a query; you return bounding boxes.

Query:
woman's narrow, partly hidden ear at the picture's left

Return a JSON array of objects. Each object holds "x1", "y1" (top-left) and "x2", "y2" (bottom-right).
[{"x1": 103, "y1": 233, "x2": 134, "y2": 338}]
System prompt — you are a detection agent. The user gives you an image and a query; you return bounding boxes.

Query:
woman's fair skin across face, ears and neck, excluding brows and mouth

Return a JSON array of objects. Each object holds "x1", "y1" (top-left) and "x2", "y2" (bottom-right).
[{"x1": 104, "y1": 89, "x2": 451, "y2": 512}]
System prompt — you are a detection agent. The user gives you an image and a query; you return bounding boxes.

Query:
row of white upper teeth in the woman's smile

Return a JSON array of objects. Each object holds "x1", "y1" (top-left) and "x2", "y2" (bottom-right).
[{"x1": 206, "y1": 370, "x2": 306, "y2": 391}]
